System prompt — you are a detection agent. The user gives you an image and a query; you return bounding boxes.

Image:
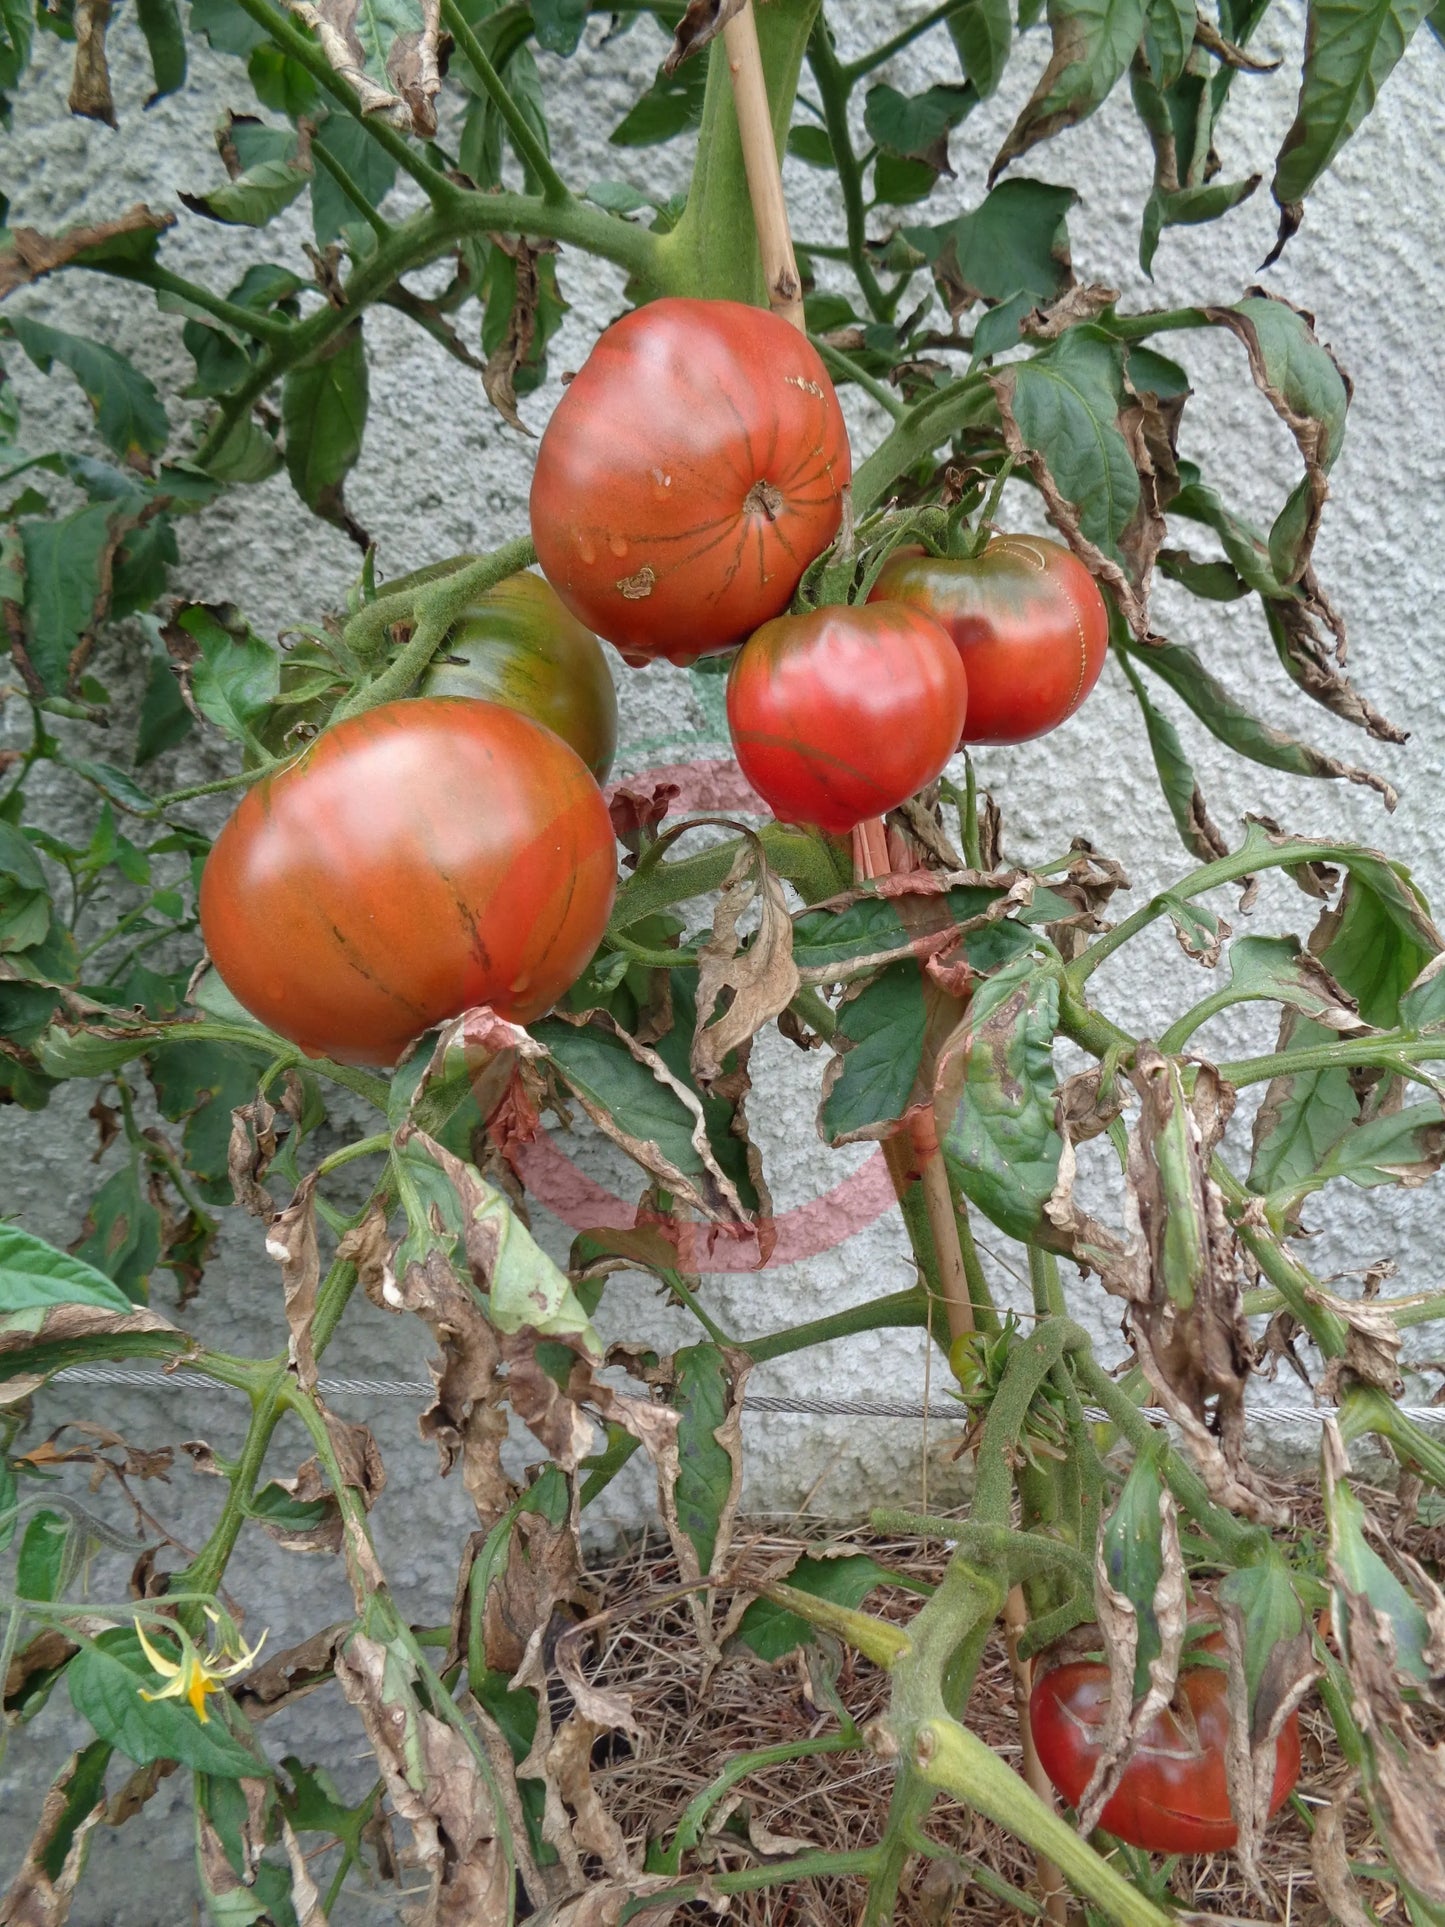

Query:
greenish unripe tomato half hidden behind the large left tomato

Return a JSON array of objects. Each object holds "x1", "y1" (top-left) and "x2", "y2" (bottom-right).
[{"x1": 418, "y1": 572, "x2": 617, "y2": 782}]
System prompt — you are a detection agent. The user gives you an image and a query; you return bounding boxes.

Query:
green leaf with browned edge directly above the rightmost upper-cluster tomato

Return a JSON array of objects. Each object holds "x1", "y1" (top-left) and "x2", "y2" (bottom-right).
[{"x1": 994, "y1": 328, "x2": 1139, "y2": 561}]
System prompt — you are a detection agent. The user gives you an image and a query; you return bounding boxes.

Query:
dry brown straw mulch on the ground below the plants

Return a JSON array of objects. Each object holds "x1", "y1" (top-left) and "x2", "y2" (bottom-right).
[{"x1": 588, "y1": 1490, "x2": 1437, "y2": 1927}]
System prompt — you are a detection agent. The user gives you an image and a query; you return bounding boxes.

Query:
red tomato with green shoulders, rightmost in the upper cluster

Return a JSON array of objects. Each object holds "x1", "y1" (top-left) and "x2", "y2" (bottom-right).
[{"x1": 869, "y1": 536, "x2": 1110, "y2": 742}]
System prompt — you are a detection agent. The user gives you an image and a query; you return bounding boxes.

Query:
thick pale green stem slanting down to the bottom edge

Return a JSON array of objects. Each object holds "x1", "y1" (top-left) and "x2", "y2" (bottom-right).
[{"x1": 913, "y1": 1719, "x2": 1169, "y2": 1927}]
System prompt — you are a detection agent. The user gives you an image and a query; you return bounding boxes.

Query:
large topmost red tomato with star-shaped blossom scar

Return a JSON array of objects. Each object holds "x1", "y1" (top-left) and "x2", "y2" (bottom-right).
[{"x1": 532, "y1": 299, "x2": 852, "y2": 665}]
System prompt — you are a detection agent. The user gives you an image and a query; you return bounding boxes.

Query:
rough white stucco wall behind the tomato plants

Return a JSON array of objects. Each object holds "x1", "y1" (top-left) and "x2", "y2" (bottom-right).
[{"x1": 0, "y1": 0, "x2": 1445, "y2": 1927}]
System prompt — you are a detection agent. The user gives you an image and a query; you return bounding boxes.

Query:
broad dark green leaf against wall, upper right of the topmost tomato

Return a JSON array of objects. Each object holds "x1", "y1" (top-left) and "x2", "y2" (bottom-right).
[{"x1": 902, "y1": 181, "x2": 1079, "y2": 306}]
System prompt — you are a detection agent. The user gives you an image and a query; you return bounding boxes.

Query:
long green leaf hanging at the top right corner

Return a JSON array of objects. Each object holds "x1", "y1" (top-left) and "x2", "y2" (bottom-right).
[{"x1": 1274, "y1": 0, "x2": 1432, "y2": 208}]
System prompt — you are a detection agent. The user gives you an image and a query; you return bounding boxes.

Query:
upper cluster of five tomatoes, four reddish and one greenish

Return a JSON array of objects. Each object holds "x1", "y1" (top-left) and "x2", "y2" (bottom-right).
[{"x1": 200, "y1": 299, "x2": 1108, "y2": 1064}]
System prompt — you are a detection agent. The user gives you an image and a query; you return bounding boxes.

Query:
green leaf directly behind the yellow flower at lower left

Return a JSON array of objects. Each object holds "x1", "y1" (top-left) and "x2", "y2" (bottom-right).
[{"x1": 66, "y1": 1626, "x2": 270, "y2": 1779}]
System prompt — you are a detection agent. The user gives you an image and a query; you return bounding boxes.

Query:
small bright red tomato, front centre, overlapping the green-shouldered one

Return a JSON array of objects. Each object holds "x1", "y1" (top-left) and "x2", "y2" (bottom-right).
[{"x1": 728, "y1": 603, "x2": 969, "y2": 834}]
